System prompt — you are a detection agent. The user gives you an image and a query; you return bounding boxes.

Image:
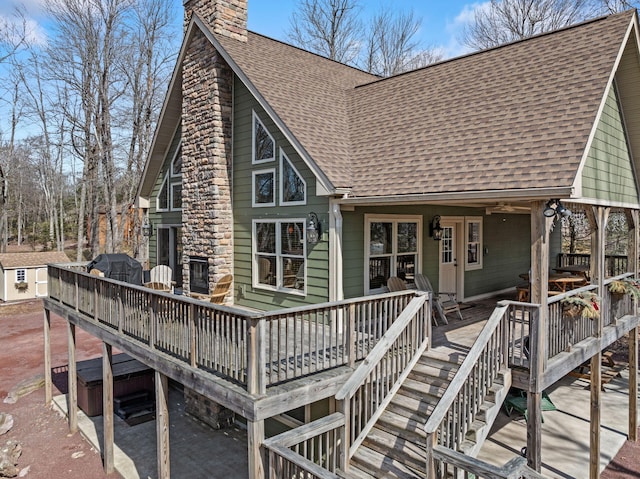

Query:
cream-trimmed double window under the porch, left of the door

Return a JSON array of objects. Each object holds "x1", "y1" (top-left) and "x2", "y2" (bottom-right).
[{"x1": 365, "y1": 215, "x2": 422, "y2": 293}]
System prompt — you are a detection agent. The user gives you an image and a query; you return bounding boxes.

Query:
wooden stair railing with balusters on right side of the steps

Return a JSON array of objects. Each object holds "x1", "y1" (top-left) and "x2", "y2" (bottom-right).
[{"x1": 424, "y1": 305, "x2": 509, "y2": 479}]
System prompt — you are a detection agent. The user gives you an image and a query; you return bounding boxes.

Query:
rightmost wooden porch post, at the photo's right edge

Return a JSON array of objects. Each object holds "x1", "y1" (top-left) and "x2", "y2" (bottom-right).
[{"x1": 625, "y1": 210, "x2": 640, "y2": 442}]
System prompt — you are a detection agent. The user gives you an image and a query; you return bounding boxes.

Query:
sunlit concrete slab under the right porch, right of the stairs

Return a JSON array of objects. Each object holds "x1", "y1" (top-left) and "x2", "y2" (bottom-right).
[{"x1": 478, "y1": 369, "x2": 629, "y2": 479}]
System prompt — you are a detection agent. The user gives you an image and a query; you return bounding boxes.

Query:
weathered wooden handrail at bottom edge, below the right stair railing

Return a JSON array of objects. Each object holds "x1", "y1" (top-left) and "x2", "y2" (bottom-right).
[{"x1": 433, "y1": 446, "x2": 546, "y2": 479}]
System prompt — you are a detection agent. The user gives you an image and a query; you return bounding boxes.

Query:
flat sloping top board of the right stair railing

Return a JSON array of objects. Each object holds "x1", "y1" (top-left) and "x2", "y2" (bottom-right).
[{"x1": 424, "y1": 305, "x2": 508, "y2": 434}]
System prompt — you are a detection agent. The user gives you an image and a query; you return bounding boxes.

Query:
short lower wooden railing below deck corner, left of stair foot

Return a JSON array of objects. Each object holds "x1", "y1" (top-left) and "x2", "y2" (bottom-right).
[{"x1": 263, "y1": 413, "x2": 345, "y2": 479}]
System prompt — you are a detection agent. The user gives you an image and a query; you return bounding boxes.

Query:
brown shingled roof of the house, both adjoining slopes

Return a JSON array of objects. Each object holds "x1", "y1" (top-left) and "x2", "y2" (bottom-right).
[{"x1": 215, "y1": 12, "x2": 635, "y2": 200}]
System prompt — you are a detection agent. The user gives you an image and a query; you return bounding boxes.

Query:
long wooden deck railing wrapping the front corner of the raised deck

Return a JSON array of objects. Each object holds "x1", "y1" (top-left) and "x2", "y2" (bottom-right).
[{"x1": 49, "y1": 265, "x2": 415, "y2": 394}]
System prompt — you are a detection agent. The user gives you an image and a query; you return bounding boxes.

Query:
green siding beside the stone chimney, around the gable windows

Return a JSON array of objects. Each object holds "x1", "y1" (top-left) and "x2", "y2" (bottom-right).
[{"x1": 233, "y1": 78, "x2": 329, "y2": 310}]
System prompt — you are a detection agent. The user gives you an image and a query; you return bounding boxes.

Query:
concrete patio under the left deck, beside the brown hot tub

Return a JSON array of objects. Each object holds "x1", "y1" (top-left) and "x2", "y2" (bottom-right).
[{"x1": 54, "y1": 388, "x2": 248, "y2": 479}]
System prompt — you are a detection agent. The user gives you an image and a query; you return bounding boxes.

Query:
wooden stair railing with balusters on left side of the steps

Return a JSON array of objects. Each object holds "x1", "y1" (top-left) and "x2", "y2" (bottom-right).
[{"x1": 335, "y1": 292, "x2": 431, "y2": 470}]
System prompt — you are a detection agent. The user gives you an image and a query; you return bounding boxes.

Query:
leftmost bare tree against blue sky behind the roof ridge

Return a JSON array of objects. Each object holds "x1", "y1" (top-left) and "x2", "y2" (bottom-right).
[{"x1": 287, "y1": 0, "x2": 362, "y2": 64}]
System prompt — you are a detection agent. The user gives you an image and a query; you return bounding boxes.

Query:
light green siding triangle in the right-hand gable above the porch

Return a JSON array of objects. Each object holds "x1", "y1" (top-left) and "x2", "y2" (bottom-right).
[{"x1": 582, "y1": 88, "x2": 638, "y2": 204}]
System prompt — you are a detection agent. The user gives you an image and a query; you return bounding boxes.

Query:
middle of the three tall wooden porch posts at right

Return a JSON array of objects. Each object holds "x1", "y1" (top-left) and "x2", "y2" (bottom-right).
[{"x1": 589, "y1": 207, "x2": 610, "y2": 479}]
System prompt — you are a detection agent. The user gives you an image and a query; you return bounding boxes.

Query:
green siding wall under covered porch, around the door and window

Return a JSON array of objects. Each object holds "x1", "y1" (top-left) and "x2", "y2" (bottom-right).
[{"x1": 342, "y1": 206, "x2": 560, "y2": 298}]
